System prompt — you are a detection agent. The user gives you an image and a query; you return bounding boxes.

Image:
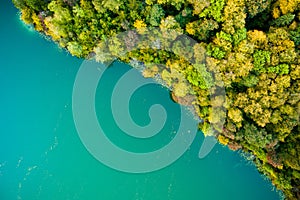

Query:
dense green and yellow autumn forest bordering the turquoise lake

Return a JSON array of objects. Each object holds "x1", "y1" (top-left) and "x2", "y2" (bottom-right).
[{"x1": 13, "y1": 0, "x2": 300, "y2": 200}]
